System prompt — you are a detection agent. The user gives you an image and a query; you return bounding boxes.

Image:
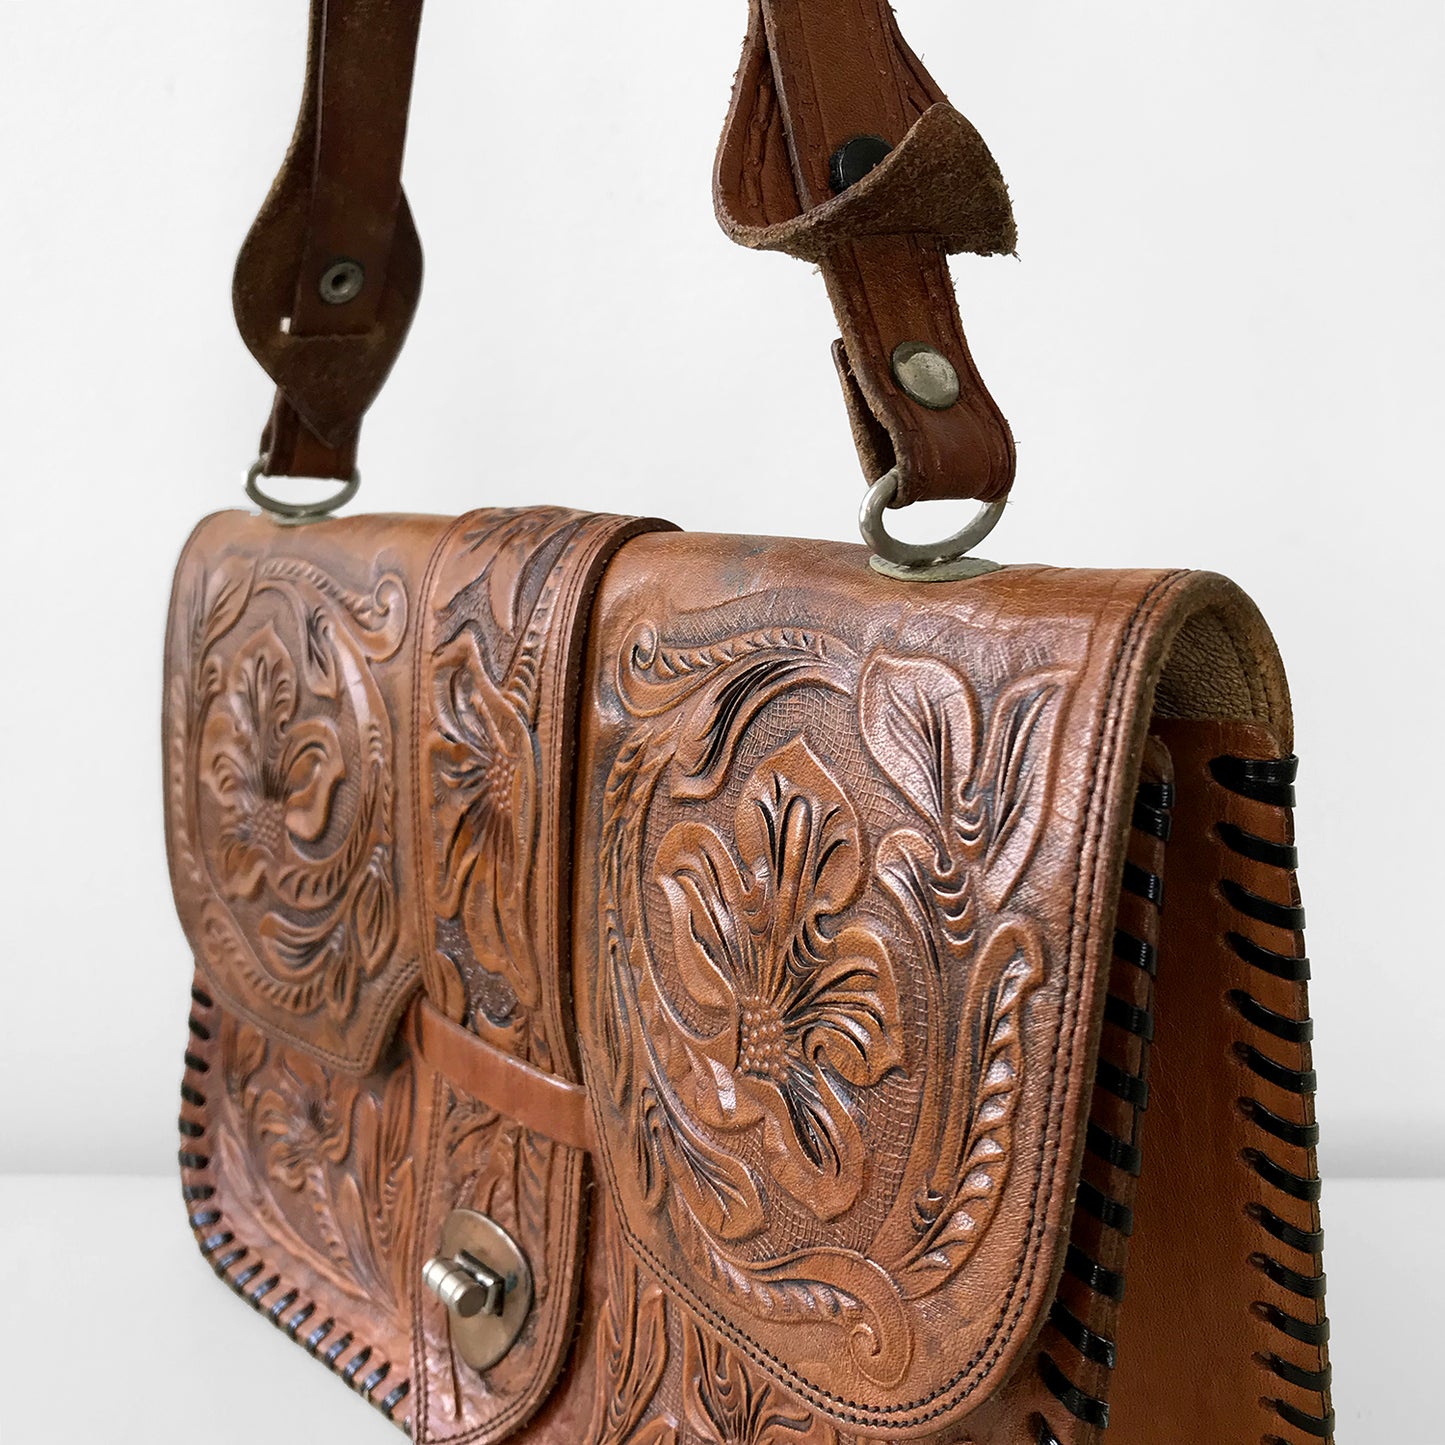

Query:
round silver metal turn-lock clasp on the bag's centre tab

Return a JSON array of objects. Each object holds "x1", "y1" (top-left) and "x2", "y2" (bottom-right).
[{"x1": 422, "y1": 1209, "x2": 532, "y2": 1370}]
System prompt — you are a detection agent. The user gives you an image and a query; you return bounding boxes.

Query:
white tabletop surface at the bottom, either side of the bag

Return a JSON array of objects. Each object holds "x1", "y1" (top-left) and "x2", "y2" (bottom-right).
[{"x1": 0, "y1": 1176, "x2": 1427, "y2": 1445}]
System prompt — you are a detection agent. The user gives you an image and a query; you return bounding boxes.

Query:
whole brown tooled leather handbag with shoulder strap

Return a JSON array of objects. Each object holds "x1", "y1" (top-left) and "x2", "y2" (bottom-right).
[{"x1": 165, "y1": 0, "x2": 1332, "y2": 1445}]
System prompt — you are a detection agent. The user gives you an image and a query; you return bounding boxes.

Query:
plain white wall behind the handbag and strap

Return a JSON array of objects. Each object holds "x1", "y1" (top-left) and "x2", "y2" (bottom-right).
[{"x1": 0, "y1": 0, "x2": 1445, "y2": 1173}]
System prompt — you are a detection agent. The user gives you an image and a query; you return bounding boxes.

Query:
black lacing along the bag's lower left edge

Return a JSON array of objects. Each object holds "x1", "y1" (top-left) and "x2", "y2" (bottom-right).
[{"x1": 179, "y1": 987, "x2": 412, "y2": 1435}]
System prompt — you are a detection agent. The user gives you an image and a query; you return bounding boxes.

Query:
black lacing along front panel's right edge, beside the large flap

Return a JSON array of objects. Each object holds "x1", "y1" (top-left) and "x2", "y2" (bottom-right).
[{"x1": 1036, "y1": 782, "x2": 1173, "y2": 1445}]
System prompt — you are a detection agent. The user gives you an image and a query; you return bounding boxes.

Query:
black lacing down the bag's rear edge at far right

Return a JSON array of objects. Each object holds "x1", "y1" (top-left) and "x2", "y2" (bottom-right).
[{"x1": 1209, "y1": 756, "x2": 1335, "y2": 1445}]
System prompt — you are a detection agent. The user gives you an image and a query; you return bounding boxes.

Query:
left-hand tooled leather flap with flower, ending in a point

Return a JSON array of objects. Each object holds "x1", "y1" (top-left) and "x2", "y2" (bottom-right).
[{"x1": 165, "y1": 513, "x2": 444, "y2": 1074}]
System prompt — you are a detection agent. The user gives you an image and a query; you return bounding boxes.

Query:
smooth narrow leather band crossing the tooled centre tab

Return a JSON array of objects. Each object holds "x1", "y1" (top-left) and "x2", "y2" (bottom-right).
[{"x1": 416, "y1": 998, "x2": 594, "y2": 1150}]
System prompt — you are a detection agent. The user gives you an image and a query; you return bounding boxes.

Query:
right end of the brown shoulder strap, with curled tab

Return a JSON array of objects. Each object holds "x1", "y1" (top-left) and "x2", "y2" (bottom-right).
[{"x1": 715, "y1": 0, "x2": 1014, "y2": 506}]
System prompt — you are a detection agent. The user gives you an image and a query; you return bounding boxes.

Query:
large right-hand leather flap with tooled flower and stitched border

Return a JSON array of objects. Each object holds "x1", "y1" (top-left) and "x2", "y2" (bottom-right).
[{"x1": 575, "y1": 535, "x2": 1283, "y2": 1438}]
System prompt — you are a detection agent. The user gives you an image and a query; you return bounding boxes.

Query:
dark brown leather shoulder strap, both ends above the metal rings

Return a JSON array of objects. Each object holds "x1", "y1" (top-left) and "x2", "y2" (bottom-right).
[{"x1": 234, "y1": 0, "x2": 1014, "y2": 506}]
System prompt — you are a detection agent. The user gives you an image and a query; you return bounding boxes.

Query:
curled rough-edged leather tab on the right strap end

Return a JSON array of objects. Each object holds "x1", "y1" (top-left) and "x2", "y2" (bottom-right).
[{"x1": 717, "y1": 94, "x2": 1019, "y2": 260}]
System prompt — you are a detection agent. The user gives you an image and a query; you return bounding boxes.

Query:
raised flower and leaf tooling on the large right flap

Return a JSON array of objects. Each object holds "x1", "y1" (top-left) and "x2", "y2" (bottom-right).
[{"x1": 590, "y1": 609, "x2": 1064, "y2": 1384}]
